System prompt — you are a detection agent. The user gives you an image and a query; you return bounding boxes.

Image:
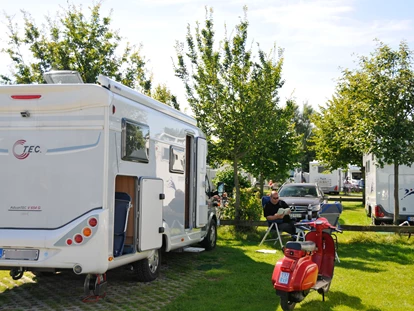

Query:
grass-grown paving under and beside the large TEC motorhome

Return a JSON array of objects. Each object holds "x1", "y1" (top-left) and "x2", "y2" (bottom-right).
[{"x1": 0, "y1": 253, "x2": 204, "y2": 311}]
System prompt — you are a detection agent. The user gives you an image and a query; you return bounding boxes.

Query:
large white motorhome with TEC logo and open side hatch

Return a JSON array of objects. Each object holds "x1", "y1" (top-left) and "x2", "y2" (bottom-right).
[{"x1": 0, "y1": 72, "x2": 217, "y2": 295}]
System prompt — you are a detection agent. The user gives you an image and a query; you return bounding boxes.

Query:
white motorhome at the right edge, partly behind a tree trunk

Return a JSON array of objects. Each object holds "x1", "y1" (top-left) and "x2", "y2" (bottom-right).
[{"x1": 363, "y1": 154, "x2": 414, "y2": 225}]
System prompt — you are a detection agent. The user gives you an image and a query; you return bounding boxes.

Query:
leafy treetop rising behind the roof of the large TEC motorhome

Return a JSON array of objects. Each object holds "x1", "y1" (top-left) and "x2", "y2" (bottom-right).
[{"x1": 0, "y1": 2, "x2": 178, "y2": 108}]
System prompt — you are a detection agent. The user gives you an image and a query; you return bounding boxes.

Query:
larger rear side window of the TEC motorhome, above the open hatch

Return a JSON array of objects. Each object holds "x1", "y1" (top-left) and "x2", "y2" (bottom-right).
[{"x1": 121, "y1": 119, "x2": 149, "y2": 163}]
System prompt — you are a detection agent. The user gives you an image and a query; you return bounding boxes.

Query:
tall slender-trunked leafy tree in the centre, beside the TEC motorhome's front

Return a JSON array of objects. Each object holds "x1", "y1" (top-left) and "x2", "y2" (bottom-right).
[{"x1": 175, "y1": 8, "x2": 294, "y2": 220}]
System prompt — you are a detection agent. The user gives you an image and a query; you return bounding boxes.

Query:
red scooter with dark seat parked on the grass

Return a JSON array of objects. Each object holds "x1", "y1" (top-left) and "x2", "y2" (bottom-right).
[{"x1": 272, "y1": 217, "x2": 342, "y2": 311}]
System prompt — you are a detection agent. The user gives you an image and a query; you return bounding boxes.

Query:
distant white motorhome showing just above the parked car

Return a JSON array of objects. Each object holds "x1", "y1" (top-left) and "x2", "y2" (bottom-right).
[{"x1": 309, "y1": 161, "x2": 341, "y2": 194}]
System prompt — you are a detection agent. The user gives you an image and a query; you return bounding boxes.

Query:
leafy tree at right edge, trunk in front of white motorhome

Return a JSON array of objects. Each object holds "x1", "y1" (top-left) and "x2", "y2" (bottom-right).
[{"x1": 354, "y1": 42, "x2": 414, "y2": 225}]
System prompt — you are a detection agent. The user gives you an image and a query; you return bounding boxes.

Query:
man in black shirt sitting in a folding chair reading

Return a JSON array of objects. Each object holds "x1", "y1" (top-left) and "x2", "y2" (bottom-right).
[{"x1": 264, "y1": 190, "x2": 296, "y2": 235}]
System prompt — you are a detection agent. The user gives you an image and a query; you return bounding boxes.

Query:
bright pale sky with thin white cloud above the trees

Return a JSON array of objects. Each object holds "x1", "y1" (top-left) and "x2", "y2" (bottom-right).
[{"x1": 0, "y1": 0, "x2": 414, "y2": 114}]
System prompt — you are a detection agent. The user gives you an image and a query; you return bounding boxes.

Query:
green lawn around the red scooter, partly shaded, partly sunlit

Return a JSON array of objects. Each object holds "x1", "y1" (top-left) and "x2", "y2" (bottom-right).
[{"x1": 162, "y1": 202, "x2": 414, "y2": 311}]
